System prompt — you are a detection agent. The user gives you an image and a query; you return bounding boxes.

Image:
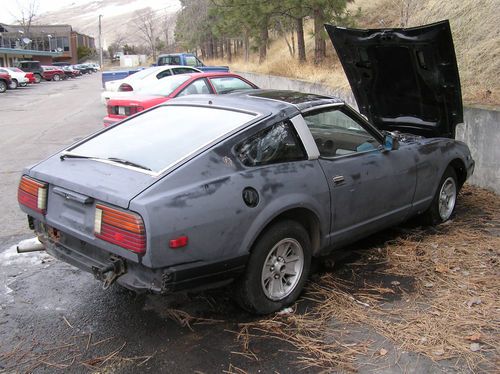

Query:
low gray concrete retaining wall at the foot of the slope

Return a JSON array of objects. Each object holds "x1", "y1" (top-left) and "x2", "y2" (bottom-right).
[{"x1": 238, "y1": 72, "x2": 500, "y2": 194}]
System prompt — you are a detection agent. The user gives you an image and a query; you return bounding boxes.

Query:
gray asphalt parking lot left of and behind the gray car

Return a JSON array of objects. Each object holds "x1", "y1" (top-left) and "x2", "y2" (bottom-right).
[{"x1": 0, "y1": 74, "x2": 296, "y2": 373}]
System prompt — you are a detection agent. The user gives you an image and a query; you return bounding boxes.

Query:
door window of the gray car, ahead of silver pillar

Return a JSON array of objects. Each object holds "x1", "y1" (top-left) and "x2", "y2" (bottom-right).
[{"x1": 304, "y1": 108, "x2": 380, "y2": 157}]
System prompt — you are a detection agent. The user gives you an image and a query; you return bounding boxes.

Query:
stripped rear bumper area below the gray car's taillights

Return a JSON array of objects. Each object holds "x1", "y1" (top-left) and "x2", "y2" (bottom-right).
[{"x1": 35, "y1": 222, "x2": 248, "y2": 294}]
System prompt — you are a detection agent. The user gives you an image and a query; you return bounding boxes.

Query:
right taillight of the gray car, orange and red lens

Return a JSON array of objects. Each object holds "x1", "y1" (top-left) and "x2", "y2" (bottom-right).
[{"x1": 94, "y1": 204, "x2": 146, "y2": 253}]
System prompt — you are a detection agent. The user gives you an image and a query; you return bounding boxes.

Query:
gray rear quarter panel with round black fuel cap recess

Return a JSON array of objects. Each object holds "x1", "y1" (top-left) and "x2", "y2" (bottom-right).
[{"x1": 130, "y1": 117, "x2": 330, "y2": 268}]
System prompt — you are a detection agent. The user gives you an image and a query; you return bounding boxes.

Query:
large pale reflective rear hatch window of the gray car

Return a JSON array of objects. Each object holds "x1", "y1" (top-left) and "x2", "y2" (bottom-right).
[{"x1": 69, "y1": 105, "x2": 257, "y2": 172}]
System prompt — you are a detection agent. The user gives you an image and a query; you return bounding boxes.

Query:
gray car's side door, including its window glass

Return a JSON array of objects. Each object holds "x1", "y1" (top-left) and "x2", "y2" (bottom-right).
[{"x1": 303, "y1": 106, "x2": 416, "y2": 246}]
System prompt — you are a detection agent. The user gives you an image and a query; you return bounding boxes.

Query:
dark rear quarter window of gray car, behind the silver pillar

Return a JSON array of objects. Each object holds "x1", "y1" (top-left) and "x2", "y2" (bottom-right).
[{"x1": 235, "y1": 121, "x2": 306, "y2": 166}]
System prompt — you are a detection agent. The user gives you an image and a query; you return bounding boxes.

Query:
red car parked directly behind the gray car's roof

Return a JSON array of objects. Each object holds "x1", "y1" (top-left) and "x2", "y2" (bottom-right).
[{"x1": 104, "y1": 72, "x2": 258, "y2": 127}]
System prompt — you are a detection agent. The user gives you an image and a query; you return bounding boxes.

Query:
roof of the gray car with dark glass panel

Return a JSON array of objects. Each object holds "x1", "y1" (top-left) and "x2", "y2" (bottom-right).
[{"x1": 162, "y1": 89, "x2": 344, "y2": 113}]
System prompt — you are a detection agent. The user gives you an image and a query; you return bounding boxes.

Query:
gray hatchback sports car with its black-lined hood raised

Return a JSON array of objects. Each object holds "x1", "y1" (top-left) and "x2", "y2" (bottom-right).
[{"x1": 18, "y1": 22, "x2": 474, "y2": 313}]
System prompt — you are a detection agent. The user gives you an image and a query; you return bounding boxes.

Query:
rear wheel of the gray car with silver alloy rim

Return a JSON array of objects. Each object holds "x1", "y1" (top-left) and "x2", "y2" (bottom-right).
[{"x1": 235, "y1": 220, "x2": 312, "y2": 314}]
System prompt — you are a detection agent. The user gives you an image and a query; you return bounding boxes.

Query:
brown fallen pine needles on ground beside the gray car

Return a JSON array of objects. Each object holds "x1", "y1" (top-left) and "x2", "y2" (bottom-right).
[{"x1": 236, "y1": 187, "x2": 500, "y2": 372}]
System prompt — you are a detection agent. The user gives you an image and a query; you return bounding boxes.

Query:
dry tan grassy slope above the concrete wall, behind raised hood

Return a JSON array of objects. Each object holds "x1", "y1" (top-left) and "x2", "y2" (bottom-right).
[{"x1": 206, "y1": 0, "x2": 500, "y2": 107}]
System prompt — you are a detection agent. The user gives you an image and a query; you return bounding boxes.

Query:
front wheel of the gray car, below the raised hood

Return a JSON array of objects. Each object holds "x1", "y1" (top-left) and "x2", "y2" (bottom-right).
[{"x1": 422, "y1": 166, "x2": 459, "y2": 225}]
